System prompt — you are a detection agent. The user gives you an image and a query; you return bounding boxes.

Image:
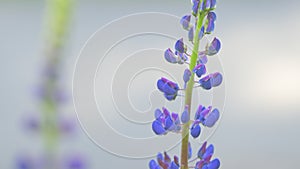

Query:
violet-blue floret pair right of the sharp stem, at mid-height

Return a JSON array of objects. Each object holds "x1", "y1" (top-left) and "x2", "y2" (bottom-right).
[{"x1": 199, "y1": 72, "x2": 223, "y2": 90}]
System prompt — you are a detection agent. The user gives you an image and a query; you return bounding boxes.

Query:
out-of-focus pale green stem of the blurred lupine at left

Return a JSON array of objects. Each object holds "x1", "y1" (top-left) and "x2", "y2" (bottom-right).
[{"x1": 41, "y1": 0, "x2": 72, "y2": 166}]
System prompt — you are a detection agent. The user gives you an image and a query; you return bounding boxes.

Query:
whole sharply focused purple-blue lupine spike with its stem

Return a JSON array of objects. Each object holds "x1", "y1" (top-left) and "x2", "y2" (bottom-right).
[{"x1": 149, "y1": 0, "x2": 223, "y2": 169}]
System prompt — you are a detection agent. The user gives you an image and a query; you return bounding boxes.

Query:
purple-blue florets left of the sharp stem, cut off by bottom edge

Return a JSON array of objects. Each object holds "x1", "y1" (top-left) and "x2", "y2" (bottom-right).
[{"x1": 149, "y1": 152, "x2": 179, "y2": 169}]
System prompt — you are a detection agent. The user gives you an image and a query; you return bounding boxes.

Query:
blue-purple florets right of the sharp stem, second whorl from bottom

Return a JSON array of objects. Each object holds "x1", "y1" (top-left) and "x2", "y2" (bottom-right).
[{"x1": 194, "y1": 105, "x2": 220, "y2": 127}]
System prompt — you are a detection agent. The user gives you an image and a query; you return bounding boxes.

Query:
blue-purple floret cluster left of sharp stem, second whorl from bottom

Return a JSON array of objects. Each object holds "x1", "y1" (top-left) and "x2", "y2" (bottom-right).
[{"x1": 152, "y1": 108, "x2": 181, "y2": 135}]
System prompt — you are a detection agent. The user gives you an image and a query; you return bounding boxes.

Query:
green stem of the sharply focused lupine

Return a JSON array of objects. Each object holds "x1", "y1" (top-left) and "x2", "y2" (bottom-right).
[{"x1": 181, "y1": 12, "x2": 205, "y2": 169}]
